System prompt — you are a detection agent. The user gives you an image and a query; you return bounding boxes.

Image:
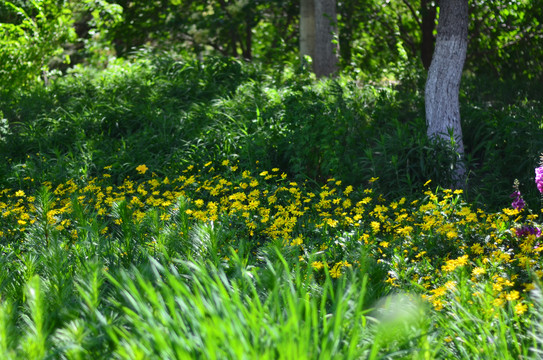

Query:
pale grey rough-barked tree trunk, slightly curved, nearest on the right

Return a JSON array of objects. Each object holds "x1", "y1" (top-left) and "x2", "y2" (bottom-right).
[{"x1": 425, "y1": 0, "x2": 469, "y2": 187}]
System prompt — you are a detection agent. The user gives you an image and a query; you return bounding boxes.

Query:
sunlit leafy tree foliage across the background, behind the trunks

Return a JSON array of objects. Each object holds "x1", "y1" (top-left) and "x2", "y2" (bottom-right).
[{"x1": 0, "y1": 0, "x2": 543, "y2": 86}]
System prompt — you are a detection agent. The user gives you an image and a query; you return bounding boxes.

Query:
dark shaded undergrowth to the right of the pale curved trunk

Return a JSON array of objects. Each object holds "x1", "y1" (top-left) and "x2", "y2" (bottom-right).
[{"x1": 461, "y1": 77, "x2": 543, "y2": 208}]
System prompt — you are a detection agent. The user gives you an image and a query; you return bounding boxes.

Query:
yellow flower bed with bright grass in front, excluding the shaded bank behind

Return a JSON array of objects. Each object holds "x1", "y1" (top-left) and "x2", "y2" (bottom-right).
[{"x1": 0, "y1": 160, "x2": 542, "y2": 358}]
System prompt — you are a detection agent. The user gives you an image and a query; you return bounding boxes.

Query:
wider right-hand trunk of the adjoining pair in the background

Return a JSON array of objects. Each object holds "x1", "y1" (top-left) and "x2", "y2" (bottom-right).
[{"x1": 313, "y1": 0, "x2": 338, "y2": 77}]
